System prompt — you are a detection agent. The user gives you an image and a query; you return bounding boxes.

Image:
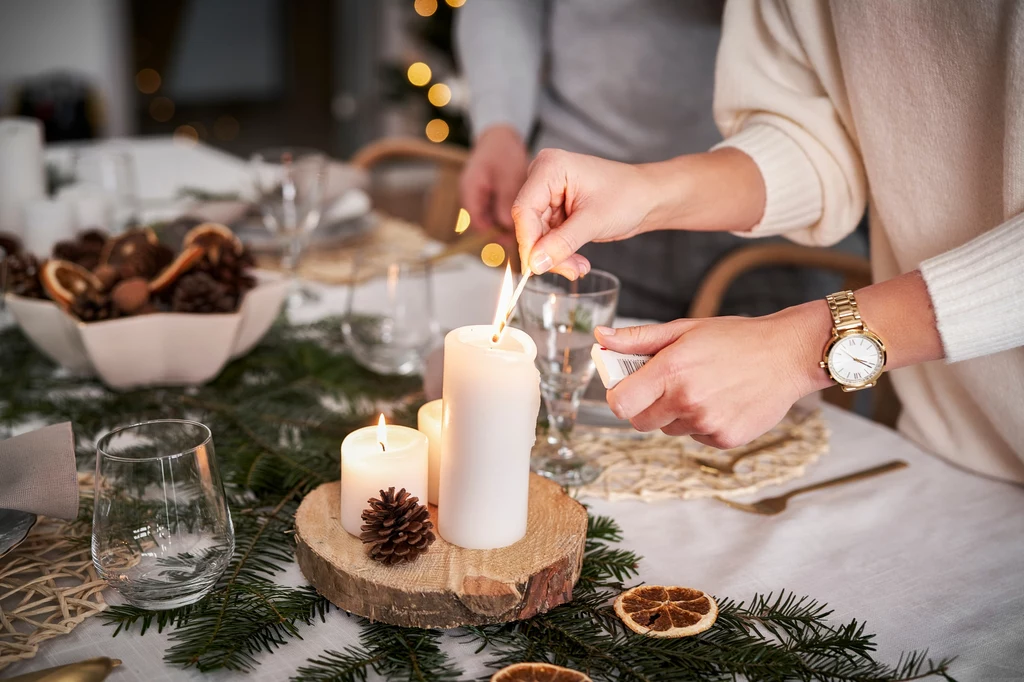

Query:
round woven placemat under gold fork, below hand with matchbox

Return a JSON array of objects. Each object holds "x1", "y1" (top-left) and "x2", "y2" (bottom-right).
[{"x1": 572, "y1": 408, "x2": 829, "y2": 502}]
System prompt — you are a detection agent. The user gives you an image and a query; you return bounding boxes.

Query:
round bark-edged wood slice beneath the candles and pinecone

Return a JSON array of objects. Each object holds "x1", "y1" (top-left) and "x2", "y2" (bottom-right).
[{"x1": 295, "y1": 474, "x2": 587, "y2": 628}]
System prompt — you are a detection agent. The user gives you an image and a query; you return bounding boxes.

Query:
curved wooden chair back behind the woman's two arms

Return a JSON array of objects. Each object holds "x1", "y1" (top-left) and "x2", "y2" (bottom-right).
[{"x1": 689, "y1": 244, "x2": 900, "y2": 427}]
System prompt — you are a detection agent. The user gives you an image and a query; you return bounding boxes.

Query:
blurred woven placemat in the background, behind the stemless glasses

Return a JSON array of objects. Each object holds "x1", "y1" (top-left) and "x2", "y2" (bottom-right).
[{"x1": 256, "y1": 215, "x2": 493, "y2": 285}]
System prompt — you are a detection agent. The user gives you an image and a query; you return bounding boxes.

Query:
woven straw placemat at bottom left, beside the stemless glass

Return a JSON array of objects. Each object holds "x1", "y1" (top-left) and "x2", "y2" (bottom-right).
[{"x1": 0, "y1": 474, "x2": 106, "y2": 671}]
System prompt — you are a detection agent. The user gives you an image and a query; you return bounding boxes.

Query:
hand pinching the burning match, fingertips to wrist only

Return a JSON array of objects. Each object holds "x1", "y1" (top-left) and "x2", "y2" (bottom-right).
[{"x1": 512, "y1": 150, "x2": 656, "y2": 280}]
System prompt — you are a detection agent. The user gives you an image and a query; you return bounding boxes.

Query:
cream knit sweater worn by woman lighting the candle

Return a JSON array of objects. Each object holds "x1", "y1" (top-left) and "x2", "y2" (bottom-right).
[{"x1": 715, "y1": 0, "x2": 1024, "y2": 481}]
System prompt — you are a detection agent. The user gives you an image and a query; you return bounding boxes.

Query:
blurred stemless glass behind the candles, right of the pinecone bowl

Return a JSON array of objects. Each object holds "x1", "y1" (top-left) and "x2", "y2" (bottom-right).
[{"x1": 342, "y1": 248, "x2": 440, "y2": 375}]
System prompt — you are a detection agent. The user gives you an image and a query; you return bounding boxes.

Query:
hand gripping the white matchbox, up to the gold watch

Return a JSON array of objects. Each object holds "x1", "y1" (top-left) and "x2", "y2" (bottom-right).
[{"x1": 596, "y1": 302, "x2": 830, "y2": 449}]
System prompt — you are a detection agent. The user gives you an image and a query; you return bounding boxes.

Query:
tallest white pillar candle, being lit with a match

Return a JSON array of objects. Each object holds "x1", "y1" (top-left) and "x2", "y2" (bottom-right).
[{"x1": 437, "y1": 323, "x2": 541, "y2": 549}]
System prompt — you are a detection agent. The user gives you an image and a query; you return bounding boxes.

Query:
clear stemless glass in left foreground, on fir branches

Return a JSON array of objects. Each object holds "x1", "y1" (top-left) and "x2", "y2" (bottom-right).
[{"x1": 92, "y1": 419, "x2": 234, "y2": 609}]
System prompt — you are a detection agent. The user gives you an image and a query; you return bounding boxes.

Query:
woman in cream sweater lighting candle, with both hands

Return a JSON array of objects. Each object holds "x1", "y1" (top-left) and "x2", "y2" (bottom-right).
[{"x1": 512, "y1": 0, "x2": 1024, "y2": 482}]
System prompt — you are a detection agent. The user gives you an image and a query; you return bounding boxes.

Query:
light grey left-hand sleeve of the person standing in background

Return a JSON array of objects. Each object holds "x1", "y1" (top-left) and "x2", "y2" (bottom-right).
[{"x1": 455, "y1": 0, "x2": 547, "y2": 140}]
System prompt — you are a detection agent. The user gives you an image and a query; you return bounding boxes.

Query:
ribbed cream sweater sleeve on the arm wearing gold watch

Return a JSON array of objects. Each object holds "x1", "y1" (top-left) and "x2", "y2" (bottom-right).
[{"x1": 921, "y1": 213, "x2": 1024, "y2": 363}]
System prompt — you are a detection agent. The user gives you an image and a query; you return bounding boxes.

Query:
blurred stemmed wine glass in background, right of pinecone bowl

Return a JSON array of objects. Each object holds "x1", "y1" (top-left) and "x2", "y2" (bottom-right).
[{"x1": 250, "y1": 146, "x2": 327, "y2": 307}]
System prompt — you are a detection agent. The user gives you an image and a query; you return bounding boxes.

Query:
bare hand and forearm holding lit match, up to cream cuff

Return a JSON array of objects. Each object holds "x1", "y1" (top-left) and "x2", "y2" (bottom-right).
[{"x1": 512, "y1": 147, "x2": 765, "y2": 280}]
